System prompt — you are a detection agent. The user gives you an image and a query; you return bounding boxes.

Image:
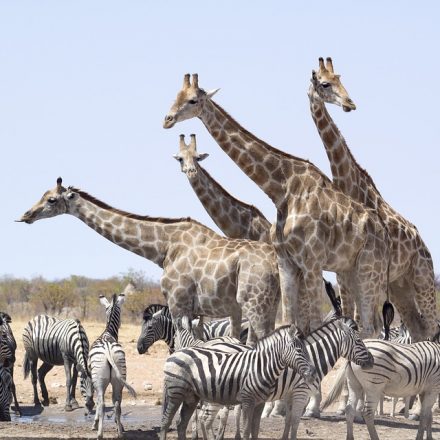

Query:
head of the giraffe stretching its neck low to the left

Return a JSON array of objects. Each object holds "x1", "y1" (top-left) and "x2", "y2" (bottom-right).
[{"x1": 17, "y1": 177, "x2": 78, "y2": 224}]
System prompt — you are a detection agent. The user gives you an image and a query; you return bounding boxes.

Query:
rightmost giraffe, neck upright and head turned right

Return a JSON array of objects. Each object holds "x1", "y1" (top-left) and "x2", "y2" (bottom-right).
[{"x1": 308, "y1": 58, "x2": 438, "y2": 341}]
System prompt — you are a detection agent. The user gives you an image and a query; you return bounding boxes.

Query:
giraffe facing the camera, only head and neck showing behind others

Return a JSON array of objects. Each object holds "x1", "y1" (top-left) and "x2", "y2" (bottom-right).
[{"x1": 173, "y1": 134, "x2": 271, "y2": 243}]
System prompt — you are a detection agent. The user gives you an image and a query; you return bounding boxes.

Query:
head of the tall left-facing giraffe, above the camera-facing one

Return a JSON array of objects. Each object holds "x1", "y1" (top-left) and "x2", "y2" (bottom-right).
[{"x1": 163, "y1": 73, "x2": 219, "y2": 128}]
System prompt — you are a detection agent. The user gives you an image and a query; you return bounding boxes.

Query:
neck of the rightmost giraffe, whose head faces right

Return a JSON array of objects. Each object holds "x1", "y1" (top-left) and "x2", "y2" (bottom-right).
[{"x1": 309, "y1": 86, "x2": 382, "y2": 209}]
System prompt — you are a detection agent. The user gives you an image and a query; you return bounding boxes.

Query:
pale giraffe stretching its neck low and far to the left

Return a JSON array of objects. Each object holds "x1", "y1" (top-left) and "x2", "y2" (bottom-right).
[{"x1": 18, "y1": 178, "x2": 280, "y2": 344}]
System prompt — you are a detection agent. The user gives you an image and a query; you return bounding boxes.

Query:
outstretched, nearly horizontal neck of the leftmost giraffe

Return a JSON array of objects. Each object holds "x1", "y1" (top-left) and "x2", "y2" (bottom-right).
[{"x1": 67, "y1": 191, "x2": 183, "y2": 267}]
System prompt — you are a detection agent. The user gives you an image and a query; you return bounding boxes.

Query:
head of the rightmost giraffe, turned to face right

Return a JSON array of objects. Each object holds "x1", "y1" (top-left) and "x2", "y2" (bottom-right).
[{"x1": 311, "y1": 58, "x2": 356, "y2": 112}]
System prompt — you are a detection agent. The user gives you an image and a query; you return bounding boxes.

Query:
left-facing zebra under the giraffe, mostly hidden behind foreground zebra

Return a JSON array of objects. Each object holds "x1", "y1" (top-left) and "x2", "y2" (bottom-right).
[{"x1": 137, "y1": 304, "x2": 249, "y2": 354}]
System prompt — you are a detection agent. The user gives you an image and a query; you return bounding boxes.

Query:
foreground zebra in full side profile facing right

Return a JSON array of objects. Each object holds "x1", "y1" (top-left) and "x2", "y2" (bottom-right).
[{"x1": 160, "y1": 325, "x2": 315, "y2": 440}]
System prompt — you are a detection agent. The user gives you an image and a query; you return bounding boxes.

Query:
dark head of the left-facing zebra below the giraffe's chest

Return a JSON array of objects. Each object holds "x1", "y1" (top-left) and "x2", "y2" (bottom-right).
[{"x1": 137, "y1": 304, "x2": 174, "y2": 354}]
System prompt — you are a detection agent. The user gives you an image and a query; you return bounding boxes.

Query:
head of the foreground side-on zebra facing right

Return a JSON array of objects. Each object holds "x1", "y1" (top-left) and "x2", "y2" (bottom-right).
[{"x1": 283, "y1": 324, "x2": 316, "y2": 384}]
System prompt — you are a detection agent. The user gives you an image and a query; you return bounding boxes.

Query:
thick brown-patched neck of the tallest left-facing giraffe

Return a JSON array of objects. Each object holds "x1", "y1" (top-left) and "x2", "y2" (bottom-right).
[{"x1": 199, "y1": 99, "x2": 295, "y2": 206}]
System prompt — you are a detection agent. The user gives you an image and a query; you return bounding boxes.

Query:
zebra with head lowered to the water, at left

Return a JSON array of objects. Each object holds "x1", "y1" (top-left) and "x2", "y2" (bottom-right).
[{"x1": 23, "y1": 315, "x2": 94, "y2": 412}]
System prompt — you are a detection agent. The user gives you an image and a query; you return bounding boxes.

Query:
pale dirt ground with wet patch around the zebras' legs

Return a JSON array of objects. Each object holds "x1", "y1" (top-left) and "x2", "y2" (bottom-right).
[{"x1": 0, "y1": 322, "x2": 440, "y2": 440}]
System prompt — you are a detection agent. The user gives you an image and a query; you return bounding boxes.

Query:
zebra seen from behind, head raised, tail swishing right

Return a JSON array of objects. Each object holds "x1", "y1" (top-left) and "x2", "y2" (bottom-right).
[{"x1": 89, "y1": 293, "x2": 136, "y2": 439}]
